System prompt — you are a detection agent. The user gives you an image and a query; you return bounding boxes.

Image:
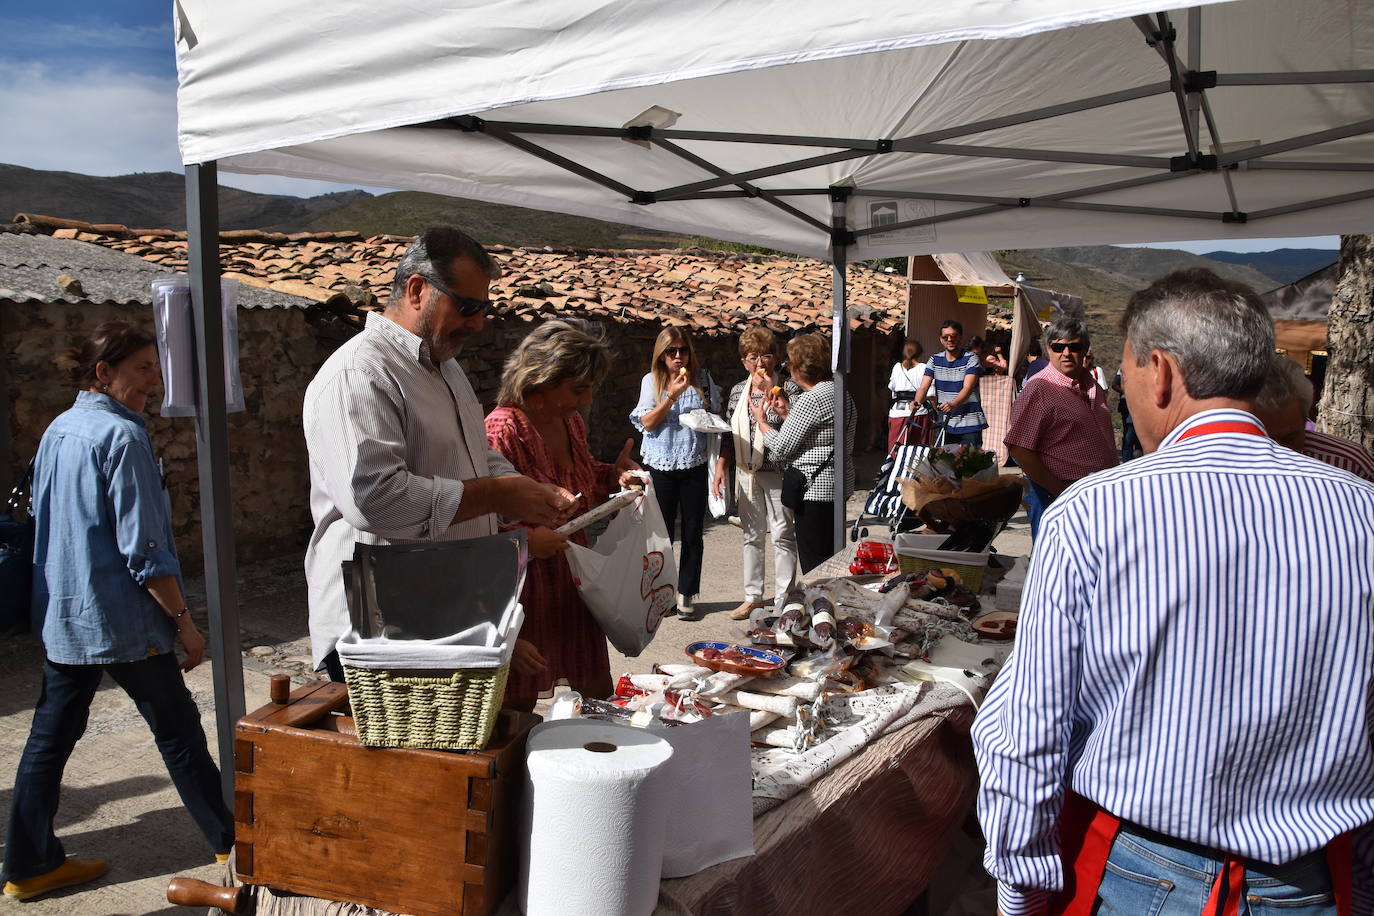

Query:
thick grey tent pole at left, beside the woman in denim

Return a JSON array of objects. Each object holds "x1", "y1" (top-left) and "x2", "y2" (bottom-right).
[{"x1": 185, "y1": 162, "x2": 245, "y2": 810}]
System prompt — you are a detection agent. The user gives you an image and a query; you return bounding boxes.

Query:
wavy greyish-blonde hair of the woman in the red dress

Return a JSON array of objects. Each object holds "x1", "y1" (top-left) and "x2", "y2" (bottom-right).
[{"x1": 496, "y1": 319, "x2": 610, "y2": 407}]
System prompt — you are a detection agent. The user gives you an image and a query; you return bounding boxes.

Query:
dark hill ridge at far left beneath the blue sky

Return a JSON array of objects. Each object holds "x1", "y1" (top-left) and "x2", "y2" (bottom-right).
[{"x1": 0, "y1": 163, "x2": 372, "y2": 232}]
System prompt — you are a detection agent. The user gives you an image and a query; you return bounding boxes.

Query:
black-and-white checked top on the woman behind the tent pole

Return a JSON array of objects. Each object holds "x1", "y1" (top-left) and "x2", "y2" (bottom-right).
[{"x1": 764, "y1": 382, "x2": 859, "y2": 503}]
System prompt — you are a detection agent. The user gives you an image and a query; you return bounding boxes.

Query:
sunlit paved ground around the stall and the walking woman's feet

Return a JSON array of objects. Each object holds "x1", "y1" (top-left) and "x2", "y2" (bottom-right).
[{"x1": 0, "y1": 456, "x2": 1029, "y2": 916}]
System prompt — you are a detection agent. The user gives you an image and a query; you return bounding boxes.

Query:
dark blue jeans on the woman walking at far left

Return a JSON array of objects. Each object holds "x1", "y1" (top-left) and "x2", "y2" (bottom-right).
[{"x1": 3, "y1": 654, "x2": 234, "y2": 880}]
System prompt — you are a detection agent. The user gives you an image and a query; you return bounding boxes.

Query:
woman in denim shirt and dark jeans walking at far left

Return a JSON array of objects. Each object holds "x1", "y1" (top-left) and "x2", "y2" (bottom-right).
[{"x1": 4, "y1": 321, "x2": 234, "y2": 900}]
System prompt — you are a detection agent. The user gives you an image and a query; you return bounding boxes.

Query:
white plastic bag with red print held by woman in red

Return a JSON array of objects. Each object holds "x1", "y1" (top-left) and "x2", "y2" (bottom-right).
[{"x1": 566, "y1": 483, "x2": 677, "y2": 658}]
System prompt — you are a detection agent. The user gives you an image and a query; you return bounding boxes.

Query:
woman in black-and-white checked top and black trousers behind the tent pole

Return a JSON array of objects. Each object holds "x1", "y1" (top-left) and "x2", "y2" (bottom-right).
[{"x1": 750, "y1": 334, "x2": 857, "y2": 573}]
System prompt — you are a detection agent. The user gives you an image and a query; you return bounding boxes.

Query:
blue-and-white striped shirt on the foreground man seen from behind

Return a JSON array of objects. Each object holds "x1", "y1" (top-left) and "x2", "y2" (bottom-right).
[{"x1": 973, "y1": 411, "x2": 1374, "y2": 916}]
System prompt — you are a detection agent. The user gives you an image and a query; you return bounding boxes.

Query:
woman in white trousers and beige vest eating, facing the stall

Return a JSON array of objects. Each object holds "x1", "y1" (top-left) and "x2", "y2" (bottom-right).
[{"x1": 710, "y1": 325, "x2": 801, "y2": 621}]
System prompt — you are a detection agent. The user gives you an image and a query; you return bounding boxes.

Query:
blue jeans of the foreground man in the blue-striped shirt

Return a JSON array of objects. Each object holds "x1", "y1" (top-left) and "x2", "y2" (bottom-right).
[{"x1": 1094, "y1": 828, "x2": 1336, "y2": 916}]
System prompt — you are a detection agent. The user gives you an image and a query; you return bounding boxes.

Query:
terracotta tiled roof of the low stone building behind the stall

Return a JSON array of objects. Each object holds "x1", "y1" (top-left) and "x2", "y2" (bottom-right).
[{"x1": 13, "y1": 217, "x2": 907, "y2": 335}]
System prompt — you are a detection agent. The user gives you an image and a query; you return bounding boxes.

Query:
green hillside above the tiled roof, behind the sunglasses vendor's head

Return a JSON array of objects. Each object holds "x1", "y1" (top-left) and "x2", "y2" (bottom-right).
[{"x1": 293, "y1": 191, "x2": 686, "y2": 249}]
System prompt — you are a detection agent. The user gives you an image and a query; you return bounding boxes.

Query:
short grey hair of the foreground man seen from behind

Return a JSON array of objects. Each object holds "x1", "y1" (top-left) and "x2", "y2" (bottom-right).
[{"x1": 1121, "y1": 268, "x2": 1274, "y2": 401}]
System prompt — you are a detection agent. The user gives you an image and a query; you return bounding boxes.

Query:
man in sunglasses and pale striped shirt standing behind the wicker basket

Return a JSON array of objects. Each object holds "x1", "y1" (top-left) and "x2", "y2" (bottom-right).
[{"x1": 302, "y1": 227, "x2": 574, "y2": 680}]
